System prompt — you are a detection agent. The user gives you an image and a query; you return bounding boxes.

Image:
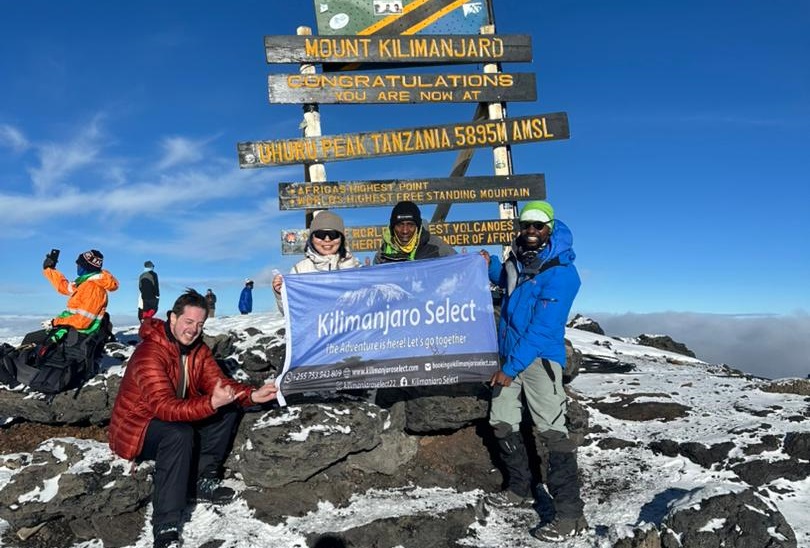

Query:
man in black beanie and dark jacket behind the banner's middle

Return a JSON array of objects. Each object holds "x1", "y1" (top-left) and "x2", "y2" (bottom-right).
[{"x1": 374, "y1": 202, "x2": 456, "y2": 264}]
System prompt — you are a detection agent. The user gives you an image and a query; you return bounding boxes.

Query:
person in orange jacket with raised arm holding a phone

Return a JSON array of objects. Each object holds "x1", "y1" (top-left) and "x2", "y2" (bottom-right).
[{"x1": 42, "y1": 249, "x2": 118, "y2": 333}]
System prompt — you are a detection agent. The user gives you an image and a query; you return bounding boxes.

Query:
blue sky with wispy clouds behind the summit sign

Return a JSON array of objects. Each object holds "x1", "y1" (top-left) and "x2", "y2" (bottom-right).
[{"x1": 0, "y1": 0, "x2": 810, "y2": 326}]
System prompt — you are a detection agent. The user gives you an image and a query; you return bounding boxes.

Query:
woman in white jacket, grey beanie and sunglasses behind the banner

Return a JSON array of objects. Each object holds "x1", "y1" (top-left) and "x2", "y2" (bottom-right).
[{"x1": 273, "y1": 210, "x2": 360, "y2": 312}]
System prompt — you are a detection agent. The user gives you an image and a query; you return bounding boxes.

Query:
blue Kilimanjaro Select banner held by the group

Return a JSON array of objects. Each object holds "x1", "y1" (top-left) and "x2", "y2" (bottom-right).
[{"x1": 278, "y1": 253, "x2": 498, "y2": 405}]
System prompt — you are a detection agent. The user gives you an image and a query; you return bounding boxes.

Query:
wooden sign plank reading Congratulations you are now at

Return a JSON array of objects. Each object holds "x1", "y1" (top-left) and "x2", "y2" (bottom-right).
[{"x1": 267, "y1": 72, "x2": 537, "y2": 104}]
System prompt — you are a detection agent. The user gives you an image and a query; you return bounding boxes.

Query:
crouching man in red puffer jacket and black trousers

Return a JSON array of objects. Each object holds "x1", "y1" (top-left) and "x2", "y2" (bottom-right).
[{"x1": 108, "y1": 289, "x2": 277, "y2": 548}]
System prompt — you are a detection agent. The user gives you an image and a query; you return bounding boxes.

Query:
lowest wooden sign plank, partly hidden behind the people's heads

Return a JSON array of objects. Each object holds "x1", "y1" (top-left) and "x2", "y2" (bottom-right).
[{"x1": 281, "y1": 219, "x2": 517, "y2": 255}]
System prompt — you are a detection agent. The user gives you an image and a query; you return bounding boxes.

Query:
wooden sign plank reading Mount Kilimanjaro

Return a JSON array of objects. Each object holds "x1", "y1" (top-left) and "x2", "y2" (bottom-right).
[{"x1": 264, "y1": 34, "x2": 532, "y2": 64}]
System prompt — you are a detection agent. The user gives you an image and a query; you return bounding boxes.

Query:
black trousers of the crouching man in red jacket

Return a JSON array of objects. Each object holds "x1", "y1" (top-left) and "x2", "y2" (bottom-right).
[{"x1": 136, "y1": 404, "x2": 241, "y2": 528}]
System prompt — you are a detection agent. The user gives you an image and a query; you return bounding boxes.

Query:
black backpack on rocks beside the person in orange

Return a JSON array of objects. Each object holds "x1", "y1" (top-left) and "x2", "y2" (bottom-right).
[{"x1": 0, "y1": 316, "x2": 112, "y2": 395}]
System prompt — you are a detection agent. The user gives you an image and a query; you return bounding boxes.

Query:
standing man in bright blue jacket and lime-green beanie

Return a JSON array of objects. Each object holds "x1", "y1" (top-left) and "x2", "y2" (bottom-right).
[{"x1": 481, "y1": 201, "x2": 588, "y2": 542}]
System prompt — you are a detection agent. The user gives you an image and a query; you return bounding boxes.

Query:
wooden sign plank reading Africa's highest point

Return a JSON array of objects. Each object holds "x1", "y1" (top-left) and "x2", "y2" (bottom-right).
[{"x1": 278, "y1": 174, "x2": 546, "y2": 211}]
